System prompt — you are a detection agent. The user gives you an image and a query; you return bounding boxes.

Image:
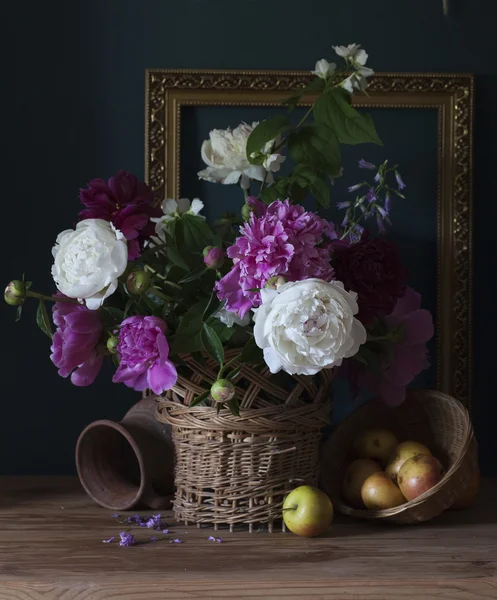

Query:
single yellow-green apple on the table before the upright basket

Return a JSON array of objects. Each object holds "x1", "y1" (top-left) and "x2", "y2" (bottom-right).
[{"x1": 283, "y1": 485, "x2": 333, "y2": 537}]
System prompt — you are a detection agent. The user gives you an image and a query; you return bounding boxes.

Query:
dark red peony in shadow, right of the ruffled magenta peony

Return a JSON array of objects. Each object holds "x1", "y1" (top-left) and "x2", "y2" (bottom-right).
[{"x1": 332, "y1": 234, "x2": 407, "y2": 325}]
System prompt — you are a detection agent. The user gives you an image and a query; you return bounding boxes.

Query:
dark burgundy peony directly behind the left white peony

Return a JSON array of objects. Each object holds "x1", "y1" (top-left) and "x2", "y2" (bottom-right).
[{"x1": 79, "y1": 171, "x2": 161, "y2": 260}]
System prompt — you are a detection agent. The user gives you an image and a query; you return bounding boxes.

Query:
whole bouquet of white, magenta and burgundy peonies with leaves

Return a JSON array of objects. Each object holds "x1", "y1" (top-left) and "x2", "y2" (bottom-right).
[{"x1": 5, "y1": 44, "x2": 433, "y2": 415}]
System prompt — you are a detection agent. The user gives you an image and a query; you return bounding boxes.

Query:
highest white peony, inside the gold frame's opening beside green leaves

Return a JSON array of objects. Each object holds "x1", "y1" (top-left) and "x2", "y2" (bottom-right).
[{"x1": 198, "y1": 122, "x2": 279, "y2": 189}]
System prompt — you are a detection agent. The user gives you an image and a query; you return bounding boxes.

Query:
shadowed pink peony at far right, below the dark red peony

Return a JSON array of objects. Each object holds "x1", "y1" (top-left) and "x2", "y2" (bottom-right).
[{"x1": 360, "y1": 288, "x2": 434, "y2": 406}]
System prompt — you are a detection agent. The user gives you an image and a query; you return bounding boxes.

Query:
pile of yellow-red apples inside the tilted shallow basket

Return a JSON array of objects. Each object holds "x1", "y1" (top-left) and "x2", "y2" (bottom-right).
[{"x1": 342, "y1": 429, "x2": 444, "y2": 510}]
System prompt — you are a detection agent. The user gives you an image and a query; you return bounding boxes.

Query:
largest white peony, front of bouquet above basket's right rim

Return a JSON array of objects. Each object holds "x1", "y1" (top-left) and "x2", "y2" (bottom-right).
[{"x1": 254, "y1": 279, "x2": 366, "y2": 375}]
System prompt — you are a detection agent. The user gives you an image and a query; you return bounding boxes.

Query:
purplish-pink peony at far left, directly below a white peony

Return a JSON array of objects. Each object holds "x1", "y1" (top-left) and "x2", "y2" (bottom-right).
[{"x1": 50, "y1": 302, "x2": 103, "y2": 386}]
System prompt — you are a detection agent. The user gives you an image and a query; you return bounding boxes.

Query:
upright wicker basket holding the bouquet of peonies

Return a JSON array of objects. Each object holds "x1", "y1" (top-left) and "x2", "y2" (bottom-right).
[{"x1": 157, "y1": 351, "x2": 332, "y2": 532}]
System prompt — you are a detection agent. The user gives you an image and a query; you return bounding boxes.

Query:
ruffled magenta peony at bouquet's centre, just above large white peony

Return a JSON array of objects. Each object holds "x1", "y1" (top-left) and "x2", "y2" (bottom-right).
[{"x1": 216, "y1": 198, "x2": 334, "y2": 318}]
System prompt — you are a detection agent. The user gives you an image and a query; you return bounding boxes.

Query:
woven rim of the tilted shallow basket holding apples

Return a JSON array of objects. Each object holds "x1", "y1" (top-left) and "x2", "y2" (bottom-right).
[{"x1": 325, "y1": 390, "x2": 476, "y2": 519}]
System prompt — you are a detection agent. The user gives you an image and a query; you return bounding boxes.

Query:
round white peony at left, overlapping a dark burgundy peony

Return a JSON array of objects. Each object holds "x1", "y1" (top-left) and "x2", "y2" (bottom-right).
[{"x1": 52, "y1": 219, "x2": 128, "y2": 310}]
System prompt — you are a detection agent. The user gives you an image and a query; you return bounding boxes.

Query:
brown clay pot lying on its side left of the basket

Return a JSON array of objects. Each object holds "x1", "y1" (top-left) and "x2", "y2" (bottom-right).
[{"x1": 76, "y1": 397, "x2": 174, "y2": 511}]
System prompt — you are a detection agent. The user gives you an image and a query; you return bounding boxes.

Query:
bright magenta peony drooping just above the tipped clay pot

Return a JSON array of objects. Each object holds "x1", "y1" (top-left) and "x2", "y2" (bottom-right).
[{"x1": 112, "y1": 316, "x2": 178, "y2": 394}]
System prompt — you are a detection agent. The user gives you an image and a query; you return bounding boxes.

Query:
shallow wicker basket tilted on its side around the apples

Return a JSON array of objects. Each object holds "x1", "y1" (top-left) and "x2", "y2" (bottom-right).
[{"x1": 320, "y1": 390, "x2": 478, "y2": 524}]
